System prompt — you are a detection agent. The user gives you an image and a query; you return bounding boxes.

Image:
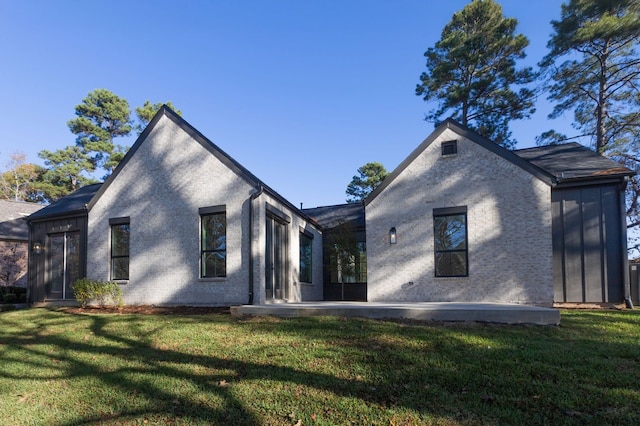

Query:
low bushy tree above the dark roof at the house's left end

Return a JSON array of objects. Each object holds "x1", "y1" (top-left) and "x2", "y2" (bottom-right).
[{"x1": 36, "y1": 146, "x2": 96, "y2": 202}]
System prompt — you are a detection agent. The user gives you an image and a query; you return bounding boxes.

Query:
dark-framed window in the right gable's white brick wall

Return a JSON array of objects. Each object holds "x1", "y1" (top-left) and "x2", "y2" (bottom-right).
[{"x1": 433, "y1": 207, "x2": 469, "y2": 277}]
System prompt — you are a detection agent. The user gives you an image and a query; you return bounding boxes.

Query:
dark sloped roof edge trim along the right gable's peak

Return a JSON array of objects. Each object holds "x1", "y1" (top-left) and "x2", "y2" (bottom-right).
[{"x1": 364, "y1": 118, "x2": 555, "y2": 206}]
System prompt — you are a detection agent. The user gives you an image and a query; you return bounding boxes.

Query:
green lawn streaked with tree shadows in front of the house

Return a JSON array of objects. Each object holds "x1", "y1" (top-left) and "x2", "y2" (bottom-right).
[{"x1": 0, "y1": 313, "x2": 640, "y2": 426}]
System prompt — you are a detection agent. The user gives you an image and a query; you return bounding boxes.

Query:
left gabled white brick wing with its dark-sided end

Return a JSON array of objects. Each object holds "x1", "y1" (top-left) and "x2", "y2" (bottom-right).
[{"x1": 31, "y1": 108, "x2": 322, "y2": 306}]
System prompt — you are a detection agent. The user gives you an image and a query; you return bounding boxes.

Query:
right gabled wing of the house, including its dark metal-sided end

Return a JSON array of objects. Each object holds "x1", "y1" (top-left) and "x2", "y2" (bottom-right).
[{"x1": 365, "y1": 120, "x2": 632, "y2": 306}]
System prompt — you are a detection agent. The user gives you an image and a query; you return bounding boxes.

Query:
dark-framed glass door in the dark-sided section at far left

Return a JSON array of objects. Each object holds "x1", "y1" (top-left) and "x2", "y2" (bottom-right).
[{"x1": 46, "y1": 232, "x2": 81, "y2": 300}]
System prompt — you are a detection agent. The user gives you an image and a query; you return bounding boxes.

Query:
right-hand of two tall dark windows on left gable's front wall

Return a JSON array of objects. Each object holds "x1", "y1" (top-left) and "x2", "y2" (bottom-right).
[{"x1": 200, "y1": 206, "x2": 227, "y2": 278}]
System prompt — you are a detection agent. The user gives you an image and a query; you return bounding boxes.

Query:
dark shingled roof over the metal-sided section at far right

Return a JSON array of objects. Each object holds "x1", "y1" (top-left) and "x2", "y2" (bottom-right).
[{"x1": 513, "y1": 142, "x2": 635, "y2": 183}]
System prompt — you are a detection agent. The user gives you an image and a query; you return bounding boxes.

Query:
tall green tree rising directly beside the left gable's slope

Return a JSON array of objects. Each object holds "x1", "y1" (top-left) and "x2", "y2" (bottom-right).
[{"x1": 67, "y1": 89, "x2": 132, "y2": 175}]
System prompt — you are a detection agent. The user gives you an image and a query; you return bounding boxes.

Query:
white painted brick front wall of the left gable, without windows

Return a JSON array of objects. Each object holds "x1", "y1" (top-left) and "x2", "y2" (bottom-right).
[{"x1": 87, "y1": 117, "x2": 255, "y2": 306}]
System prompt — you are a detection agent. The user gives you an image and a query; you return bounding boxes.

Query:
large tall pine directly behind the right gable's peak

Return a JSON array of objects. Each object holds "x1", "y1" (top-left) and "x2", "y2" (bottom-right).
[{"x1": 416, "y1": 0, "x2": 536, "y2": 148}]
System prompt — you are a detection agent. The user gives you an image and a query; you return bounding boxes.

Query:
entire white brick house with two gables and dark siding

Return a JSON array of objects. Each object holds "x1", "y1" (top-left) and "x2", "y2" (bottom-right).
[{"x1": 29, "y1": 111, "x2": 633, "y2": 306}]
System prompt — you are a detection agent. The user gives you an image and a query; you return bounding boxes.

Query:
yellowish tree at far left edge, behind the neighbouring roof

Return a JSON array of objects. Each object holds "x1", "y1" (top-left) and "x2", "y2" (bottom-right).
[{"x1": 0, "y1": 151, "x2": 38, "y2": 201}]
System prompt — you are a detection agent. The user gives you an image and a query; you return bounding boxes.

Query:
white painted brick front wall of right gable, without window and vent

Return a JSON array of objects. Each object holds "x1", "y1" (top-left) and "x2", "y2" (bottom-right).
[{"x1": 366, "y1": 129, "x2": 553, "y2": 306}]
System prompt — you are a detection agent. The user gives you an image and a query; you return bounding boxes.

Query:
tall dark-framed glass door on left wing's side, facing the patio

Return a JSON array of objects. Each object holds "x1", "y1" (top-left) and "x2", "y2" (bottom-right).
[{"x1": 266, "y1": 216, "x2": 287, "y2": 300}]
